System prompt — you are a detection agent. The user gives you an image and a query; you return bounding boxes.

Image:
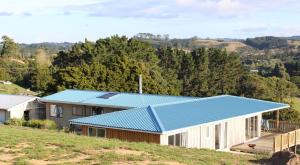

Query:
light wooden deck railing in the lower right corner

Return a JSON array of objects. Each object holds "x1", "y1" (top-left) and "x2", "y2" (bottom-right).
[{"x1": 273, "y1": 129, "x2": 300, "y2": 152}]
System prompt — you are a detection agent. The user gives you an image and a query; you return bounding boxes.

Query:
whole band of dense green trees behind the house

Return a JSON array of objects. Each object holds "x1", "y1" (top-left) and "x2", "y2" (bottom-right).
[{"x1": 0, "y1": 36, "x2": 297, "y2": 120}]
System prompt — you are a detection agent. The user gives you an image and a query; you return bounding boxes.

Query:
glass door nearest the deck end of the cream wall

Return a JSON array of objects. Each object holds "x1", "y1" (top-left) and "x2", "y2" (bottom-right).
[{"x1": 245, "y1": 116, "x2": 258, "y2": 140}]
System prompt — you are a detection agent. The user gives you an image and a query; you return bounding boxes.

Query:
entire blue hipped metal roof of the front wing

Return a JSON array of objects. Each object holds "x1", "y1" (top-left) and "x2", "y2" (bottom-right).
[{"x1": 71, "y1": 95, "x2": 289, "y2": 133}]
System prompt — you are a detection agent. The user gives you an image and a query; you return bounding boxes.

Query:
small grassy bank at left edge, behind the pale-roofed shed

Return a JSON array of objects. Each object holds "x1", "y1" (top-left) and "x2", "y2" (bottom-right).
[{"x1": 0, "y1": 84, "x2": 37, "y2": 96}]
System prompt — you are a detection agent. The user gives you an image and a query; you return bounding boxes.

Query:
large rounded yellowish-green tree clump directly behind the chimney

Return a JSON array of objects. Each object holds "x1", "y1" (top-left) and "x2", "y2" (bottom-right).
[{"x1": 53, "y1": 36, "x2": 179, "y2": 95}]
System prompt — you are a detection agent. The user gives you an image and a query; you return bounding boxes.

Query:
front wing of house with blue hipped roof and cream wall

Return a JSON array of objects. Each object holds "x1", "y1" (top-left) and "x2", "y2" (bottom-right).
[{"x1": 70, "y1": 95, "x2": 289, "y2": 150}]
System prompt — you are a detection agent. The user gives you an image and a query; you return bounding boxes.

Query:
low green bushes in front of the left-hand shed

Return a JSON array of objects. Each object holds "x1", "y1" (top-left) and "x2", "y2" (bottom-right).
[{"x1": 5, "y1": 119, "x2": 58, "y2": 130}]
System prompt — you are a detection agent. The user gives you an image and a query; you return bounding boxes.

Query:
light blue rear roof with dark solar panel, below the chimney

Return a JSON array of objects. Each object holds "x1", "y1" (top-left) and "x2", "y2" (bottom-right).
[{"x1": 41, "y1": 90, "x2": 197, "y2": 108}]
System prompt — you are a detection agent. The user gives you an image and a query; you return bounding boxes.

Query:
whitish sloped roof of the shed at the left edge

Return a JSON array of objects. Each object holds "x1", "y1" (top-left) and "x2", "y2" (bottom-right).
[{"x1": 0, "y1": 94, "x2": 36, "y2": 110}]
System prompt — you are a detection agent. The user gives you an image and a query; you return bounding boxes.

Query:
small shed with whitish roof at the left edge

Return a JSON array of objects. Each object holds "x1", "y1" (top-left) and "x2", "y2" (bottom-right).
[{"x1": 0, "y1": 94, "x2": 45, "y2": 123}]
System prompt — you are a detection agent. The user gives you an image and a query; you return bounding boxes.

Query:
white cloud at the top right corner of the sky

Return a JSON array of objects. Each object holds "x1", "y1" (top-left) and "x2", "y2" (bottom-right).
[{"x1": 176, "y1": 0, "x2": 299, "y2": 18}]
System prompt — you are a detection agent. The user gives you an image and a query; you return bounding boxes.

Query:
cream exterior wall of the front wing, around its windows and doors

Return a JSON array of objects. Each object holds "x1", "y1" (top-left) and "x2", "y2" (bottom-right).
[{"x1": 160, "y1": 114, "x2": 262, "y2": 149}]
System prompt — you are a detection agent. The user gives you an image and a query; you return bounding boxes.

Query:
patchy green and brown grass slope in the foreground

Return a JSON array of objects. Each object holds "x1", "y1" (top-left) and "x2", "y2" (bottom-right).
[{"x1": 0, "y1": 125, "x2": 263, "y2": 165}]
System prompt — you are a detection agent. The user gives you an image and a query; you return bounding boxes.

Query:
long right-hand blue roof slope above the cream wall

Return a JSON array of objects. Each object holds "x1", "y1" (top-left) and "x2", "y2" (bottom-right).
[{"x1": 153, "y1": 95, "x2": 288, "y2": 131}]
